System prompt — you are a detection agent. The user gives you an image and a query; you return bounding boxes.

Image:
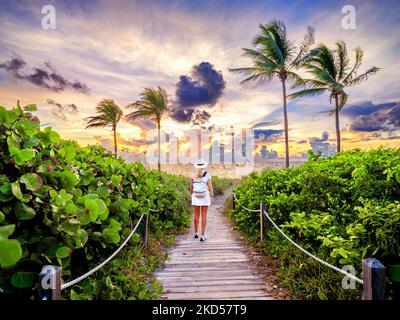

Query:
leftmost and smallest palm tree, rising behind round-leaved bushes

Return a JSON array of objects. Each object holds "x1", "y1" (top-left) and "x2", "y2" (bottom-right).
[{"x1": 85, "y1": 99, "x2": 123, "y2": 158}]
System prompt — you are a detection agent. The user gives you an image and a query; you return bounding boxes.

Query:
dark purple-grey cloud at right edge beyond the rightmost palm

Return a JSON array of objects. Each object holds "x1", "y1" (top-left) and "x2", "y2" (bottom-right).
[{"x1": 350, "y1": 103, "x2": 400, "y2": 132}]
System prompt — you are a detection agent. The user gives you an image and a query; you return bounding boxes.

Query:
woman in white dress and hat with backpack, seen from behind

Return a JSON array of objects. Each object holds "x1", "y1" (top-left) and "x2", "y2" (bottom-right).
[{"x1": 190, "y1": 159, "x2": 214, "y2": 241}]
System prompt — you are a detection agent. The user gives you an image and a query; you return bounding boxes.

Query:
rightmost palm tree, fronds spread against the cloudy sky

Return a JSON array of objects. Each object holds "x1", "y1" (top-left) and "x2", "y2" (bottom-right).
[{"x1": 288, "y1": 41, "x2": 380, "y2": 152}]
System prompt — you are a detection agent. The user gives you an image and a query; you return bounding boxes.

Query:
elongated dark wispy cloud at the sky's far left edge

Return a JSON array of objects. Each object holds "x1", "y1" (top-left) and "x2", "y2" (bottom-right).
[{"x1": 0, "y1": 56, "x2": 89, "y2": 93}]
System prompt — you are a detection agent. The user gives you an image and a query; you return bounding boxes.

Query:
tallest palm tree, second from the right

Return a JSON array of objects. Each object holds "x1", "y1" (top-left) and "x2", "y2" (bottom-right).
[{"x1": 229, "y1": 20, "x2": 315, "y2": 167}]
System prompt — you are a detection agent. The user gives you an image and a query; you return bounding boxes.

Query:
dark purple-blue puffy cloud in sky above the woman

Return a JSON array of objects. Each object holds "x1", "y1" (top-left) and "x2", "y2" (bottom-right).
[{"x1": 170, "y1": 62, "x2": 226, "y2": 122}]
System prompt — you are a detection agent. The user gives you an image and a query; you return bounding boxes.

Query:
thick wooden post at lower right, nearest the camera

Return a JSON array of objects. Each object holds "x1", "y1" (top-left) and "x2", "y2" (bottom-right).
[{"x1": 362, "y1": 258, "x2": 386, "y2": 300}]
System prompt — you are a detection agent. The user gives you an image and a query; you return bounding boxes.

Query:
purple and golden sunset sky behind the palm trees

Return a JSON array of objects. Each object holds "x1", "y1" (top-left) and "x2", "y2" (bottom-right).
[{"x1": 0, "y1": 0, "x2": 400, "y2": 155}]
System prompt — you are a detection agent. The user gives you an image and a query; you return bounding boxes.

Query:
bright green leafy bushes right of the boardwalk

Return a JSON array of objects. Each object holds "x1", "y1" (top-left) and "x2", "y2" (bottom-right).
[{"x1": 231, "y1": 149, "x2": 400, "y2": 299}]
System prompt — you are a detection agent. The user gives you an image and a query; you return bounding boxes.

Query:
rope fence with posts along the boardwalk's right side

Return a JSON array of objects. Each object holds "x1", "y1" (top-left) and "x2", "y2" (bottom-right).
[{"x1": 232, "y1": 192, "x2": 385, "y2": 300}]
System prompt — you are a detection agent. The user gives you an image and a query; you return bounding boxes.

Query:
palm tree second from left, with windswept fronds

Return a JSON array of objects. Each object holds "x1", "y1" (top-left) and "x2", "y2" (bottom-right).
[{"x1": 126, "y1": 87, "x2": 168, "y2": 171}]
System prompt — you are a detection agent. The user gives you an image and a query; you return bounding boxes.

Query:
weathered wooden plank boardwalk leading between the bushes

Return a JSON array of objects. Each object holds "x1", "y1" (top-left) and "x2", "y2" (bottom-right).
[{"x1": 155, "y1": 198, "x2": 273, "y2": 300}]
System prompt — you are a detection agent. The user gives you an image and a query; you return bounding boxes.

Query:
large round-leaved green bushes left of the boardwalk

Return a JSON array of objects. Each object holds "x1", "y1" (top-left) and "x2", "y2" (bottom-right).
[{"x1": 0, "y1": 104, "x2": 190, "y2": 298}]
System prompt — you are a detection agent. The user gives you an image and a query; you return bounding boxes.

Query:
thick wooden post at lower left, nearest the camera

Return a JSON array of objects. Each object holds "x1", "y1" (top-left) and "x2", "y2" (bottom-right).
[{"x1": 38, "y1": 266, "x2": 61, "y2": 300}]
